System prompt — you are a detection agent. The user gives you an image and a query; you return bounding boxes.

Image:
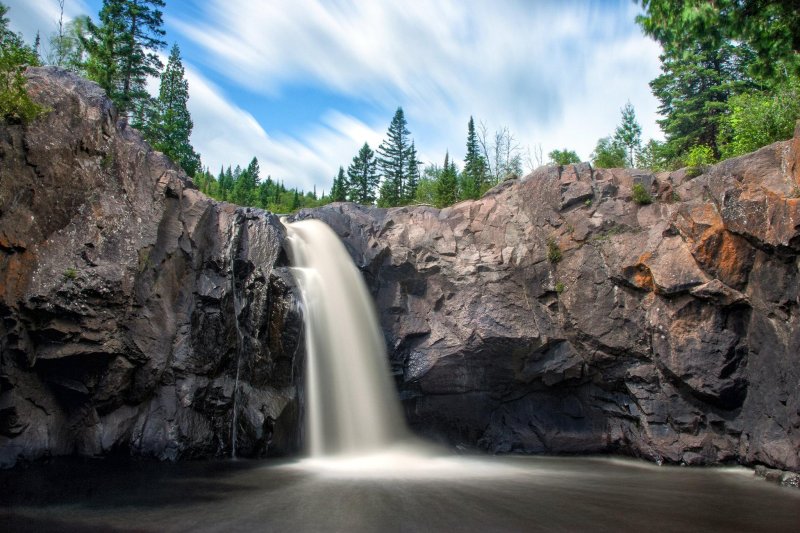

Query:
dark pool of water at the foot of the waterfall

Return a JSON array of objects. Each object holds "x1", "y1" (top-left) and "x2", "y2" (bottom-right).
[{"x1": 0, "y1": 452, "x2": 800, "y2": 532}]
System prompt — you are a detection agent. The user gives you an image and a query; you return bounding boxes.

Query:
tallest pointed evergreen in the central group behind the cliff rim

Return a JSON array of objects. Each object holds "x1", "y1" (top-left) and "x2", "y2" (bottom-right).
[{"x1": 377, "y1": 107, "x2": 410, "y2": 207}]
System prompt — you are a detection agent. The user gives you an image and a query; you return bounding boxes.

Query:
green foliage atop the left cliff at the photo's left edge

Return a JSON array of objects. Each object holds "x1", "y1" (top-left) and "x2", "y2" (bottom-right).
[{"x1": 0, "y1": 3, "x2": 46, "y2": 123}]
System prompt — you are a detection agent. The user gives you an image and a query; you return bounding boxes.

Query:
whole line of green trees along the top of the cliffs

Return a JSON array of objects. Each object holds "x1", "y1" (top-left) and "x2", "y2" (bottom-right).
[{"x1": 0, "y1": 0, "x2": 800, "y2": 212}]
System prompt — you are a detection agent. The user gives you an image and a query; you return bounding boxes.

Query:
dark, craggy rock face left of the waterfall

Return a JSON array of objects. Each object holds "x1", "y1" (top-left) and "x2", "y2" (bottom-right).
[{"x1": 0, "y1": 68, "x2": 302, "y2": 466}]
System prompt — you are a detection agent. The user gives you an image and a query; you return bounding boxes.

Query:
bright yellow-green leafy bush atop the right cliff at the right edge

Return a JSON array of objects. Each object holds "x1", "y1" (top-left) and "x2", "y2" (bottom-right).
[{"x1": 720, "y1": 78, "x2": 800, "y2": 158}]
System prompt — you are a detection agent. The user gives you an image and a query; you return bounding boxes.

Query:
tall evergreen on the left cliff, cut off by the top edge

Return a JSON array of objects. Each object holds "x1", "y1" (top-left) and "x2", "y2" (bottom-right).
[{"x1": 82, "y1": 0, "x2": 165, "y2": 114}]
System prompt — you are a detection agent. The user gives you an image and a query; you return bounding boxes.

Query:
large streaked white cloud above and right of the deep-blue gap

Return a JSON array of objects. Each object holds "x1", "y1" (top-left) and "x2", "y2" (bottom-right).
[{"x1": 170, "y1": 0, "x2": 660, "y2": 182}]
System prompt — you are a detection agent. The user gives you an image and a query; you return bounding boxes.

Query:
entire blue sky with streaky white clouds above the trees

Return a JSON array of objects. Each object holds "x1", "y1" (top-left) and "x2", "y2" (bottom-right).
[{"x1": 3, "y1": 0, "x2": 663, "y2": 193}]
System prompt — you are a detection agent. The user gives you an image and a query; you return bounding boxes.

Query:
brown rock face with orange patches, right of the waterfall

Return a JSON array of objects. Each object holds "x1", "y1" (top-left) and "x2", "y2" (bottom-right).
[{"x1": 300, "y1": 122, "x2": 800, "y2": 470}]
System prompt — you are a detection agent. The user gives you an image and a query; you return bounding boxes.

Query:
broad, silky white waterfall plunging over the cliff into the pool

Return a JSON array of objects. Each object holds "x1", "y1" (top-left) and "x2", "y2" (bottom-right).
[{"x1": 286, "y1": 220, "x2": 407, "y2": 457}]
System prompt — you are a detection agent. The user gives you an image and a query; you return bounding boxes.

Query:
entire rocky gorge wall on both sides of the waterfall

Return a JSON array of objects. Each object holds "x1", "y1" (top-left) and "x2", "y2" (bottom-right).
[{"x1": 0, "y1": 65, "x2": 800, "y2": 471}]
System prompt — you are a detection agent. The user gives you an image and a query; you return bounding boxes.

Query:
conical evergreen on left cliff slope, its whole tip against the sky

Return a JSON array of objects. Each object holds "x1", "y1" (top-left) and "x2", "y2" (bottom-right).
[{"x1": 144, "y1": 44, "x2": 202, "y2": 176}]
